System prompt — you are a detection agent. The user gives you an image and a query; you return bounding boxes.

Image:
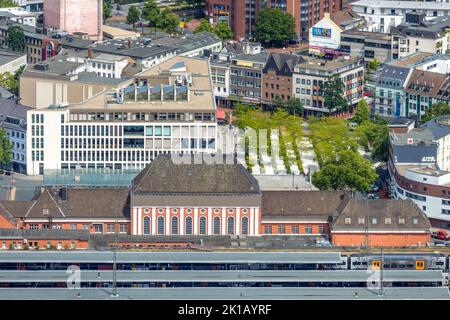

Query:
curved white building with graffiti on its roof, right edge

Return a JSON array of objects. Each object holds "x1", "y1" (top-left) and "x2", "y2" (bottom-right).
[{"x1": 388, "y1": 116, "x2": 450, "y2": 228}]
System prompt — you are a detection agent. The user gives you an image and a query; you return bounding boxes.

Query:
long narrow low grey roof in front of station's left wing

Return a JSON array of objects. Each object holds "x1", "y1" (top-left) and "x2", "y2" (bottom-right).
[{"x1": 0, "y1": 229, "x2": 90, "y2": 241}]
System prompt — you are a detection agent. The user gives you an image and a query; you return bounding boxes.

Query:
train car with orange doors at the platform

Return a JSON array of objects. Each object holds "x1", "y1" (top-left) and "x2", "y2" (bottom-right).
[{"x1": 349, "y1": 253, "x2": 447, "y2": 270}]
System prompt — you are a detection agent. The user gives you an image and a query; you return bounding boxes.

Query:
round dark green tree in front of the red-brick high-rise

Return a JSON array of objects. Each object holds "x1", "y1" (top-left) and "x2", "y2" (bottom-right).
[{"x1": 255, "y1": 8, "x2": 296, "y2": 47}]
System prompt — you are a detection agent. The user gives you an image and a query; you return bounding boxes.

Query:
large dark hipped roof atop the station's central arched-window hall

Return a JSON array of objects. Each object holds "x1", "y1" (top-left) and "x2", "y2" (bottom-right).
[{"x1": 132, "y1": 155, "x2": 260, "y2": 194}]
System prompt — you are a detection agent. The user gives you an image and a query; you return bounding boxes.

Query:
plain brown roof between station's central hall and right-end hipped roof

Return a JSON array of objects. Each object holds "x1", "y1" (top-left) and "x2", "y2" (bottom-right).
[{"x1": 262, "y1": 191, "x2": 344, "y2": 219}]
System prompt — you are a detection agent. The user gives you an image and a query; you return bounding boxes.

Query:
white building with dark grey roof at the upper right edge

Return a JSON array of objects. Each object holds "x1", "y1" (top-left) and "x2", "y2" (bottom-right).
[{"x1": 391, "y1": 13, "x2": 450, "y2": 59}]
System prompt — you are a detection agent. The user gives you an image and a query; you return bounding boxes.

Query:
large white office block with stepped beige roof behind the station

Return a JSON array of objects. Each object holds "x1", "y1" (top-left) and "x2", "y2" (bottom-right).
[{"x1": 27, "y1": 57, "x2": 217, "y2": 175}]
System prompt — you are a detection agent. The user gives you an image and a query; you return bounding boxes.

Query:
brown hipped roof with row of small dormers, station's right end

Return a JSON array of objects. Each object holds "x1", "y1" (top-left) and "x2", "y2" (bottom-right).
[{"x1": 331, "y1": 198, "x2": 431, "y2": 232}]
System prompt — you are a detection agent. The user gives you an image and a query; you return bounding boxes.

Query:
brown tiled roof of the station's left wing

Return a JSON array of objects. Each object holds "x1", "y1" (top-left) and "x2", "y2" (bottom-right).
[{"x1": 0, "y1": 188, "x2": 129, "y2": 218}]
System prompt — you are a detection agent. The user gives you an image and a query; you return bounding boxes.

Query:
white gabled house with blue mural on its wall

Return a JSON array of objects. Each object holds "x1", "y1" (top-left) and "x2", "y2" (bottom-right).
[{"x1": 309, "y1": 13, "x2": 343, "y2": 58}]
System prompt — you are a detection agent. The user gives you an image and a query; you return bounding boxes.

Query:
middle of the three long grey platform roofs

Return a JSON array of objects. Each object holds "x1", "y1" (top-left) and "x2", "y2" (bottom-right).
[{"x1": 0, "y1": 270, "x2": 444, "y2": 283}]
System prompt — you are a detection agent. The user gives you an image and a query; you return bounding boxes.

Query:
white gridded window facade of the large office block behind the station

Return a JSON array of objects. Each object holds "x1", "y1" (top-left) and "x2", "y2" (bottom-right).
[{"x1": 27, "y1": 108, "x2": 217, "y2": 175}]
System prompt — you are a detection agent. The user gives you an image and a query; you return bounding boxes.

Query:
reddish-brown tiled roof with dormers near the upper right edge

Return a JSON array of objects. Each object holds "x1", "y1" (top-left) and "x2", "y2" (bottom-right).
[{"x1": 405, "y1": 70, "x2": 447, "y2": 97}]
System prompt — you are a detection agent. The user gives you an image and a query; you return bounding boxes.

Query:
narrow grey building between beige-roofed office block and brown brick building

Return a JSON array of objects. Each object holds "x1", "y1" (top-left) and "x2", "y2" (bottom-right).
[{"x1": 229, "y1": 52, "x2": 269, "y2": 104}]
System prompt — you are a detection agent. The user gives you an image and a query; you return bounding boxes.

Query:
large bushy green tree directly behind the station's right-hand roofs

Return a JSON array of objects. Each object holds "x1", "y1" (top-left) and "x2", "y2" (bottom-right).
[{"x1": 312, "y1": 150, "x2": 377, "y2": 192}]
